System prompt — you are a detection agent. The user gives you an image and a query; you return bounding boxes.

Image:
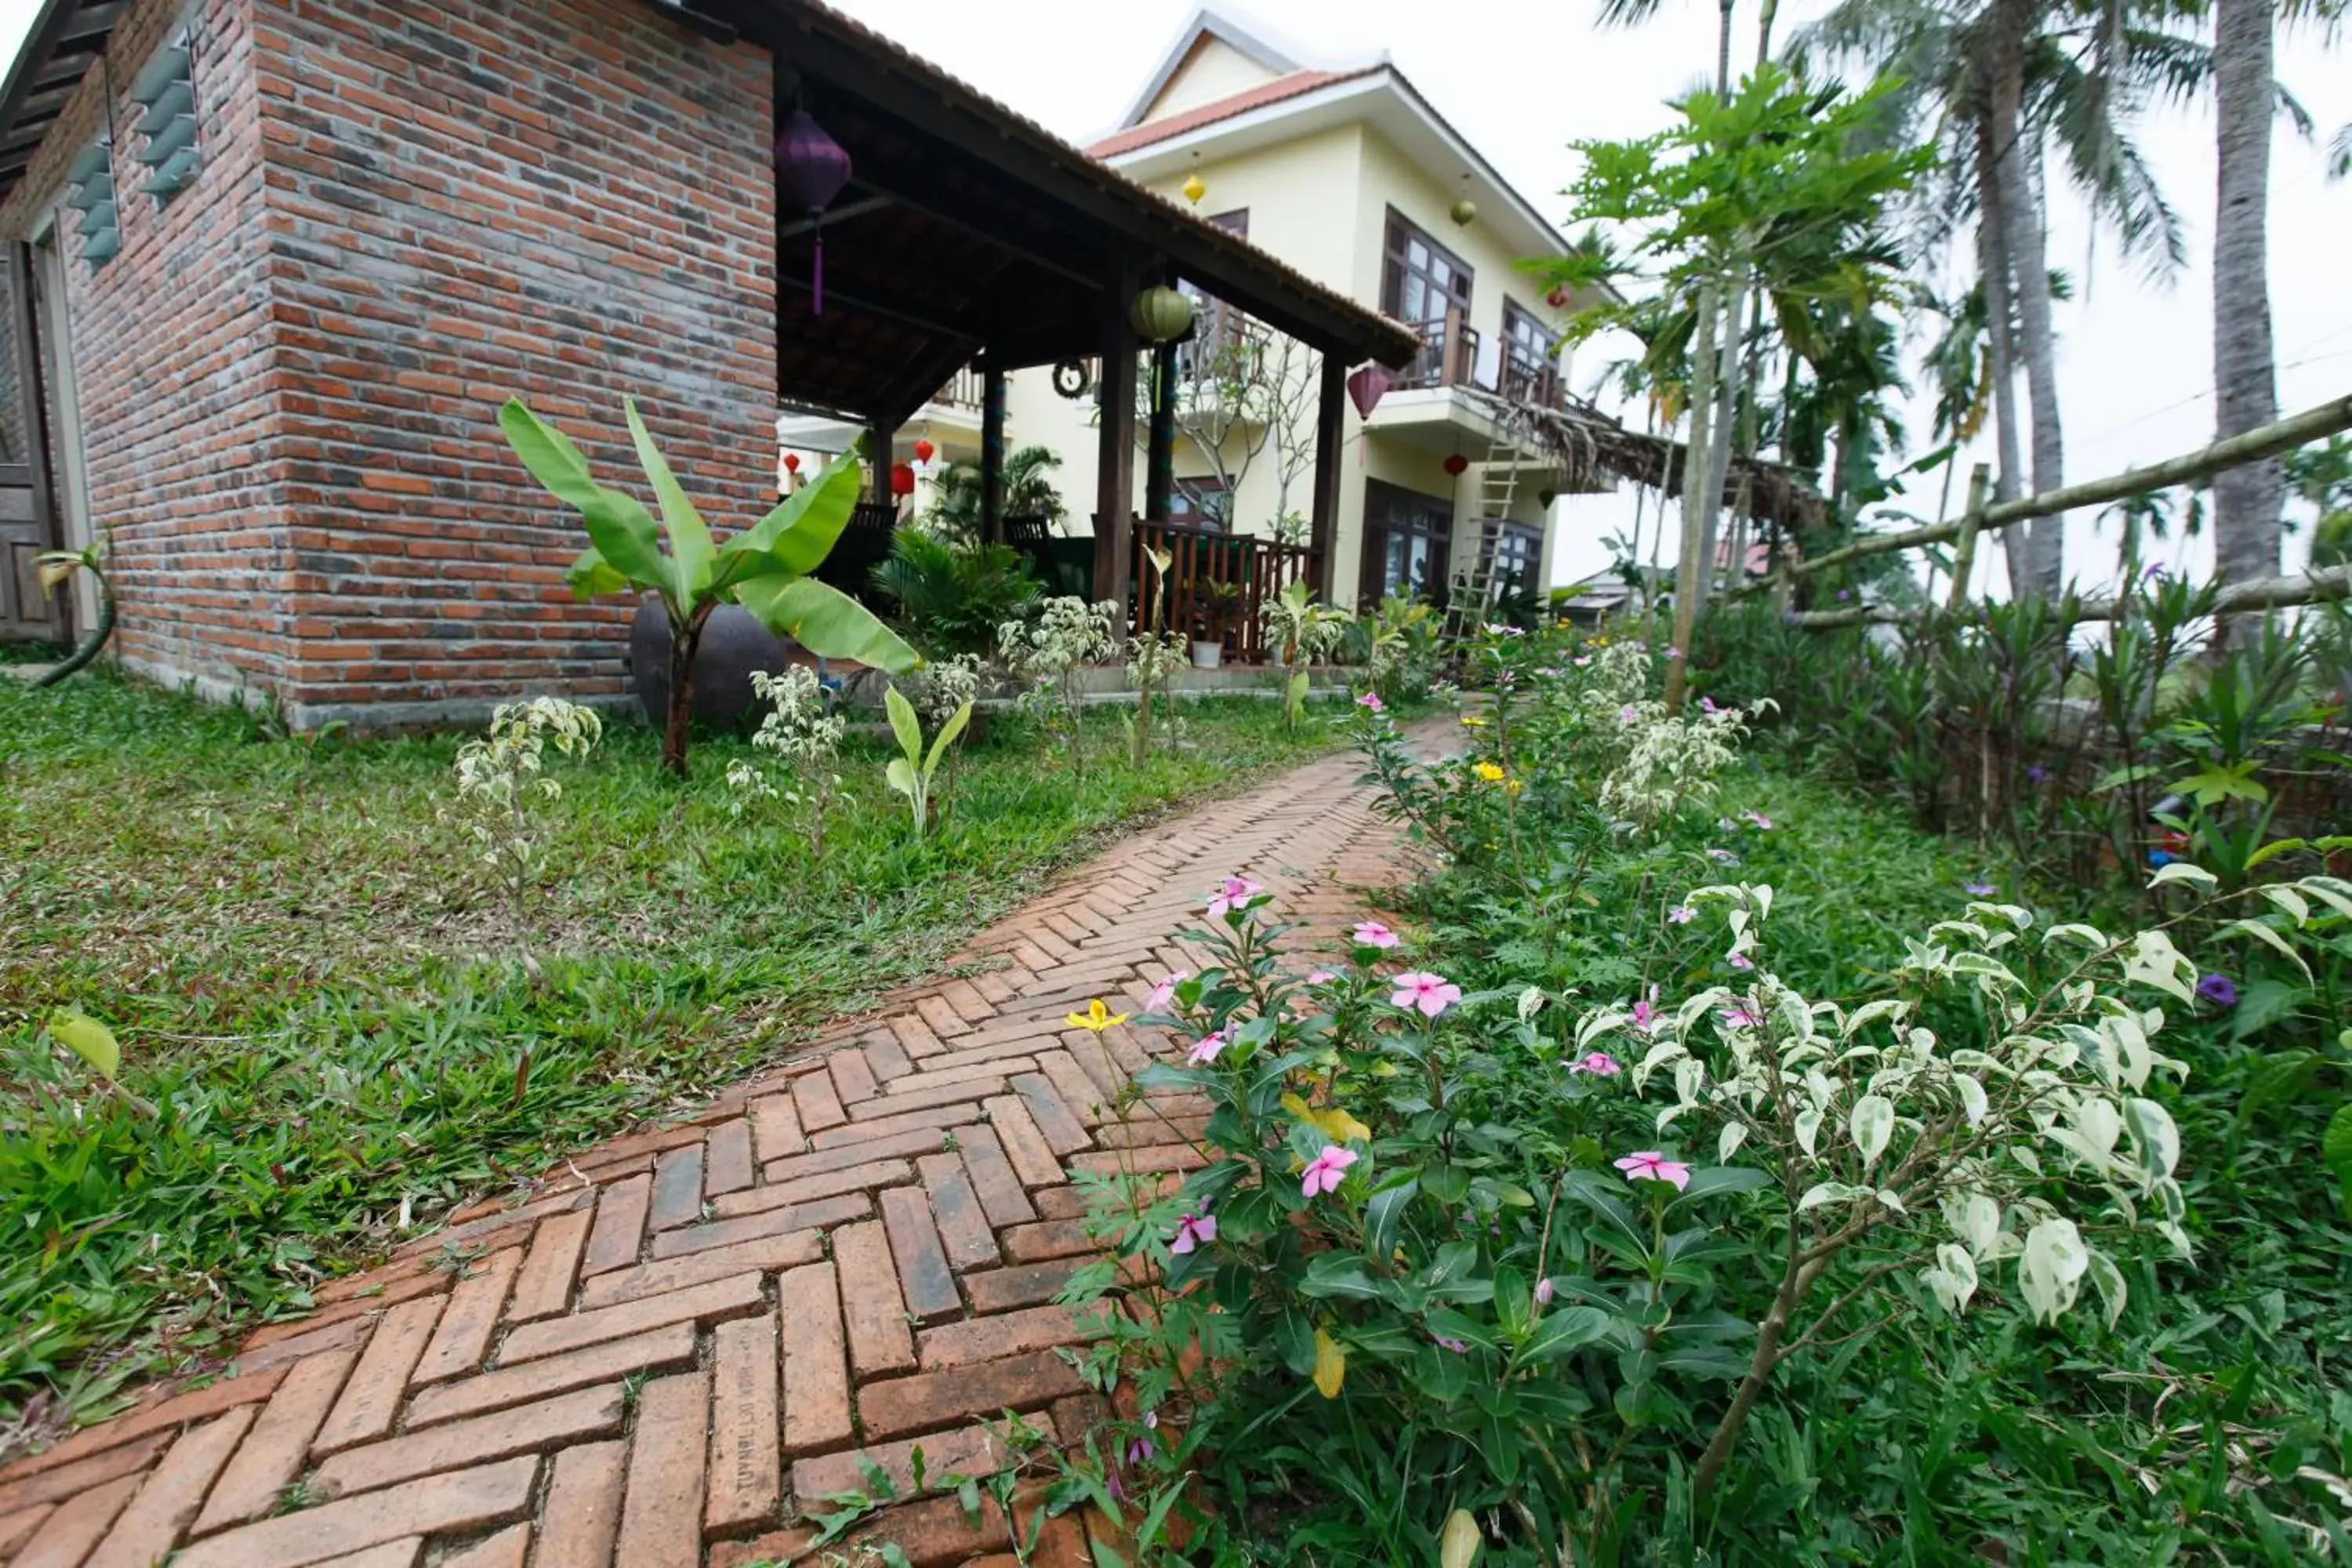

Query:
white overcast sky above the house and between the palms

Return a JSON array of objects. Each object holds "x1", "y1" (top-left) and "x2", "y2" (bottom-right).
[{"x1": 0, "y1": 0, "x2": 2352, "y2": 594}]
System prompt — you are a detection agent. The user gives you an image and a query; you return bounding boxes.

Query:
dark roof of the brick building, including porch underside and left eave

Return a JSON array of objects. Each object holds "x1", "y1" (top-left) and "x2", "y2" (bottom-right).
[{"x1": 0, "y1": 0, "x2": 1416, "y2": 423}]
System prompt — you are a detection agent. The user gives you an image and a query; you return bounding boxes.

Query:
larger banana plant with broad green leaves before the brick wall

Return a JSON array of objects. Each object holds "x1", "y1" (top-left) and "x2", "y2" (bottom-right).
[{"x1": 499, "y1": 397, "x2": 922, "y2": 779}]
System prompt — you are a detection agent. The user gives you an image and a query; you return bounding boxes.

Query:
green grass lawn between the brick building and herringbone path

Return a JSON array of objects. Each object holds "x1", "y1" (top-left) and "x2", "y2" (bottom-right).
[{"x1": 0, "y1": 675, "x2": 1334, "y2": 1450}]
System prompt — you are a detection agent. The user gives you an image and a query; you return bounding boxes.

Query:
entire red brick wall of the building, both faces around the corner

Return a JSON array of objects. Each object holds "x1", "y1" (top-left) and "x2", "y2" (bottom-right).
[{"x1": 0, "y1": 0, "x2": 776, "y2": 724}]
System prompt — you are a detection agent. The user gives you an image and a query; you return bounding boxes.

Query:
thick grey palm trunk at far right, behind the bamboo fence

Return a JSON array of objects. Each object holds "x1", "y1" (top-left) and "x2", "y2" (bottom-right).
[{"x1": 2213, "y1": 0, "x2": 2286, "y2": 597}]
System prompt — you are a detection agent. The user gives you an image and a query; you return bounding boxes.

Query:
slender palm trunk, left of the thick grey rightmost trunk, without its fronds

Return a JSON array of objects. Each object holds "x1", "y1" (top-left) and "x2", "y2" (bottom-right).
[{"x1": 1992, "y1": 0, "x2": 2065, "y2": 597}]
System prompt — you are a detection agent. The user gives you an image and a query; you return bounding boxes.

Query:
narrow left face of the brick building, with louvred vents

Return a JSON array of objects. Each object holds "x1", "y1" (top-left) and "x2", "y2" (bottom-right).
[{"x1": 0, "y1": 0, "x2": 292, "y2": 694}]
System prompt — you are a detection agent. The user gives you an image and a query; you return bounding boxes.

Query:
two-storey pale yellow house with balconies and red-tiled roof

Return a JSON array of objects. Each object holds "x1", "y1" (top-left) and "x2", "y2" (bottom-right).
[{"x1": 1007, "y1": 9, "x2": 1583, "y2": 604}]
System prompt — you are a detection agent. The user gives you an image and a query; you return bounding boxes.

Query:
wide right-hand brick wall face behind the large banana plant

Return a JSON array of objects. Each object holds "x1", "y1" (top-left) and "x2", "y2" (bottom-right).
[{"x1": 254, "y1": 0, "x2": 776, "y2": 722}]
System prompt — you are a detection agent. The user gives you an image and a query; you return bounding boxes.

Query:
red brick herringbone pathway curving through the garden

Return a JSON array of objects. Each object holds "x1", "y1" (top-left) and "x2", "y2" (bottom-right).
[{"x1": 0, "y1": 757, "x2": 1399, "y2": 1568}]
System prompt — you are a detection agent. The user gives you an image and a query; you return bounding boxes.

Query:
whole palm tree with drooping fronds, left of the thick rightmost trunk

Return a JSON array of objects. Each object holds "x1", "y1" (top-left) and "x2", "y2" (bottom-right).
[{"x1": 1792, "y1": 0, "x2": 2213, "y2": 595}]
